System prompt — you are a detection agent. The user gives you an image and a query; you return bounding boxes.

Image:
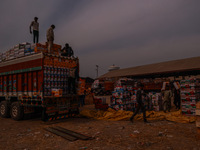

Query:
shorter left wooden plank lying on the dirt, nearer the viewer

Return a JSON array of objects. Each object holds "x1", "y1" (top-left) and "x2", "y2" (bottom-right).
[{"x1": 45, "y1": 127, "x2": 77, "y2": 141}]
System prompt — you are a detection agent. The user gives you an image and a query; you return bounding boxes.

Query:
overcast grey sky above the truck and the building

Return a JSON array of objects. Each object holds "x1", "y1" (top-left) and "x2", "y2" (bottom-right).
[{"x1": 0, "y1": 0, "x2": 200, "y2": 78}]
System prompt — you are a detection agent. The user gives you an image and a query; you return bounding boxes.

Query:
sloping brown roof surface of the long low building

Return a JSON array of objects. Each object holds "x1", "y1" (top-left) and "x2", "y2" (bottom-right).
[{"x1": 99, "y1": 57, "x2": 200, "y2": 78}]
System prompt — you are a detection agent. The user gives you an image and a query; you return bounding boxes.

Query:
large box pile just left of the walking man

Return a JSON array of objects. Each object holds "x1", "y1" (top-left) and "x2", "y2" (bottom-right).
[{"x1": 110, "y1": 80, "x2": 137, "y2": 111}]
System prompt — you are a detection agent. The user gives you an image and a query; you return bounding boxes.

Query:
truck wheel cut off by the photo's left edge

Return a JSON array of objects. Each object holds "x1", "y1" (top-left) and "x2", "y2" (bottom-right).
[{"x1": 0, "y1": 101, "x2": 10, "y2": 118}]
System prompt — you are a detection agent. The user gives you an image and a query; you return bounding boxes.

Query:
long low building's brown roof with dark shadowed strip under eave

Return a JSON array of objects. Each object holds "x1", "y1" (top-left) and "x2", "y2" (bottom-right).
[{"x1": 99, "y1": 57, "x2": 200, "y2": 79}]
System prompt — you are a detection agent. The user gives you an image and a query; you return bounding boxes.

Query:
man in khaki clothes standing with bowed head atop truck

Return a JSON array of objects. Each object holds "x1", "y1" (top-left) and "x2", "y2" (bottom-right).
[{"x1": 47, "y1": 24, "x2": 55, "y2": 53}]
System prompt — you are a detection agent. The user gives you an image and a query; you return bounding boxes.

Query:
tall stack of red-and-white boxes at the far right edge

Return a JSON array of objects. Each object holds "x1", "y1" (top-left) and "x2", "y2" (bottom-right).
[{"x1": 180, "y1": 78, "x2": 200, "y2": 115}]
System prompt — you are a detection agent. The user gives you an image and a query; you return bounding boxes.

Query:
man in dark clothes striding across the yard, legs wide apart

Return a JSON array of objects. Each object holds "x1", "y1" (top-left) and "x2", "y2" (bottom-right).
[{"x1": 130, "y1": 83, "x2": 147, "y2": 123}]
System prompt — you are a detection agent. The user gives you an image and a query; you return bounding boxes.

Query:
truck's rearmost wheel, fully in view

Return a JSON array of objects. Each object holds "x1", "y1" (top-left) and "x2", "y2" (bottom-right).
[{"x1": 10, "y1": 102, "x2": 24, "y2": 121}]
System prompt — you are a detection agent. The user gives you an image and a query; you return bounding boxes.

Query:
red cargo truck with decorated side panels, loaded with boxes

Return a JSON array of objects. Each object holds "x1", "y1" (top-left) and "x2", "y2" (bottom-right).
[{"x1": 0, "y1": 42, "x2": 79, "y2": 121}]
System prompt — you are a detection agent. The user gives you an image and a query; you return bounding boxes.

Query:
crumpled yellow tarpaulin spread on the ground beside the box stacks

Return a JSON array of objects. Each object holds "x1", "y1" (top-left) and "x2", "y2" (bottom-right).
[{"x1": 80, "y1": 108, "x2": 196, "y2": 123}]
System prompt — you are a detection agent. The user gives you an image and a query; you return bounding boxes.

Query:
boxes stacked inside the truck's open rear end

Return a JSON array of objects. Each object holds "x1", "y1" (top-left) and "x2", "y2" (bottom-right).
[{"x1": 44, "y1": 56, "x2": 77, "y2": 96}]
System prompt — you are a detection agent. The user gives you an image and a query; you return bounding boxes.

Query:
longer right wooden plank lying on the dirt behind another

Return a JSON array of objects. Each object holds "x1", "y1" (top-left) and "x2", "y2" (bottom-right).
[{"x1": 53, "y1": 126, "x2": 92, "y2": 140}]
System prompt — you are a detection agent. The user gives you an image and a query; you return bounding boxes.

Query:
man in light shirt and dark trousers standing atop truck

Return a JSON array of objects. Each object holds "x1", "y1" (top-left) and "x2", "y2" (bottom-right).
[{"x1": 29, "y1": 17, "x2": 39, "y2": 43}]
